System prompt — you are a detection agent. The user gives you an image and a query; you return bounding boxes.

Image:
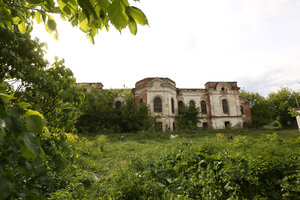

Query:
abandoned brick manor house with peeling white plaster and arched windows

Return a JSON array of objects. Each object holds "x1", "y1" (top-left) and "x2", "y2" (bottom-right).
[{"x1": 82, "y1": 77, "x2": 252, "y2": 131}]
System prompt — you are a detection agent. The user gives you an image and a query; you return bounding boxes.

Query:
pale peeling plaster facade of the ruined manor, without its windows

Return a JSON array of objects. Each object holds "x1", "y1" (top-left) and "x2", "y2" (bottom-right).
[{"x1": 135, "y1": 79, "x2": 248, "y2": 131}]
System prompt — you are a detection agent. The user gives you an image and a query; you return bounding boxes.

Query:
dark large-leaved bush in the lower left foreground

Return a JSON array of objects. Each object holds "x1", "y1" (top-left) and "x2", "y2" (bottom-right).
[{"x1": 0, "y1": 92, "x2": 77, "y2": 199}]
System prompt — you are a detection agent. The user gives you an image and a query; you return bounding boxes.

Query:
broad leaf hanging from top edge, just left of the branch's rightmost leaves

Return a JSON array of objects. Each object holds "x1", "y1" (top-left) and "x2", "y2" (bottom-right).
[{"x1": 108, "y1": 0, "x2": 129, "y2": 32}]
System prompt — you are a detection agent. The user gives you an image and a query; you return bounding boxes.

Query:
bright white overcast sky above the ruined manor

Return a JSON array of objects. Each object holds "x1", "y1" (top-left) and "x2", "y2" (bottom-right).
[{"x1": 33, "y1": 0, "x2": 300, "y2": 95}]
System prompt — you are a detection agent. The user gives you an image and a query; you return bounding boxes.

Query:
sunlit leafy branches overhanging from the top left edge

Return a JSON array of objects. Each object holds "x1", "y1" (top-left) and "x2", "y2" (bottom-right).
[{"x1": 0, "y1": 0, "x2": 148, "y2": 43}]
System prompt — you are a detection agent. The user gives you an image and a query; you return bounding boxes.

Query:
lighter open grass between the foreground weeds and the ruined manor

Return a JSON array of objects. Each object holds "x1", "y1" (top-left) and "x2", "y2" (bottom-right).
[{"x1": 74, "y1": 129, "x2": 300, "y2": 173}]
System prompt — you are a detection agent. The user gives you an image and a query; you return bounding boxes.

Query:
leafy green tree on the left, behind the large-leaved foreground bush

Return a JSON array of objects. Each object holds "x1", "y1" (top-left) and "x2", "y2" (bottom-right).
[{"x1": 0, "y1": 28, "x2": 83, "y2": 131}]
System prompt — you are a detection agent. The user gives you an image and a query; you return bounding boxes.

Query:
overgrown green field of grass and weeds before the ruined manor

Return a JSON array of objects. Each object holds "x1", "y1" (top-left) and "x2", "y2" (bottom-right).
[{"x1": 59, "y1": 129, "x2": 300, "y2": 199}]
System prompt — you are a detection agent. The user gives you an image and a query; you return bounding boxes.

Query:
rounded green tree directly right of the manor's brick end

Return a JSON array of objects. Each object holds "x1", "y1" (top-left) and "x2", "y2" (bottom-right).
[{"x1": 240, "y1": 90, "x2": 272, "y2": 127}]
